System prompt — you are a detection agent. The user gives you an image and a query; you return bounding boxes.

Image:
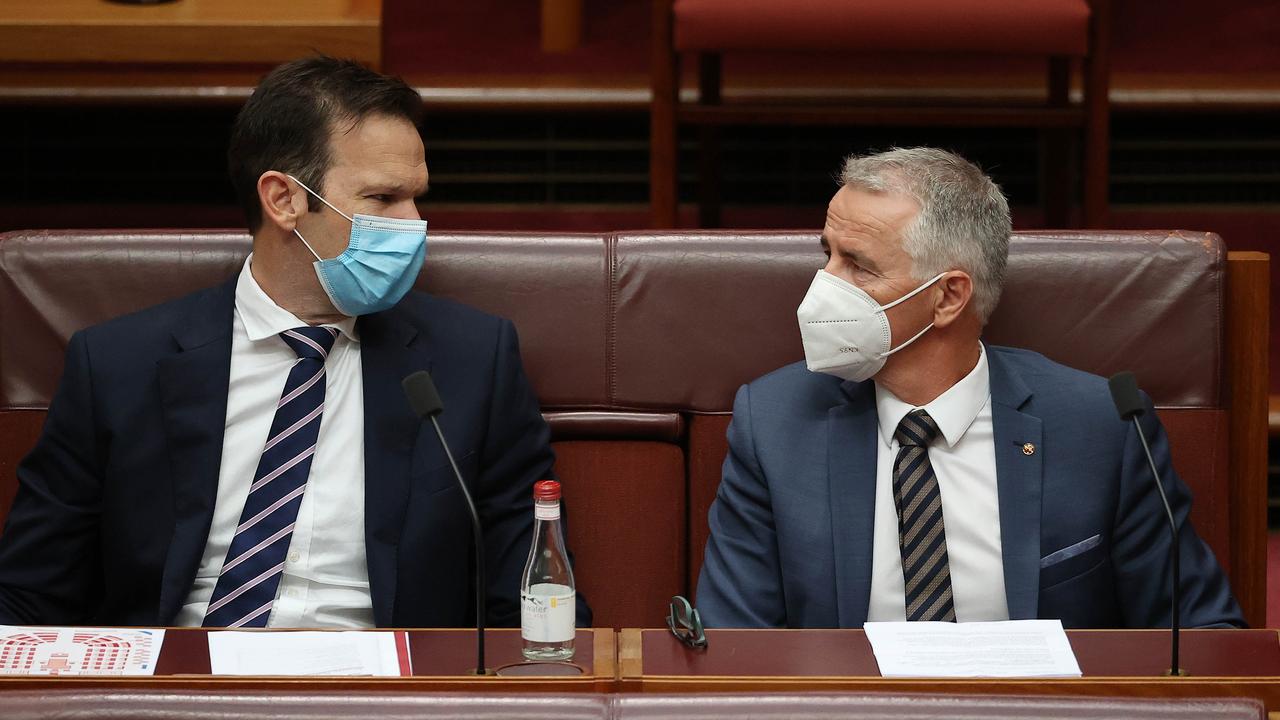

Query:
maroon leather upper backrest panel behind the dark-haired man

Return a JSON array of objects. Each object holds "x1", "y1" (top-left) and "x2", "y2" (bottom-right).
[{"x1": 0, "y1": 231, "x2": 608, "y2": 409}]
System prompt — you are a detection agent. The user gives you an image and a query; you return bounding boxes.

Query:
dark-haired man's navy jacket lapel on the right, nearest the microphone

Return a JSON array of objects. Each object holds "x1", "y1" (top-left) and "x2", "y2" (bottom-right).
[{"x1": 358, "y1": 309, "x2": 431, "y2": 626}]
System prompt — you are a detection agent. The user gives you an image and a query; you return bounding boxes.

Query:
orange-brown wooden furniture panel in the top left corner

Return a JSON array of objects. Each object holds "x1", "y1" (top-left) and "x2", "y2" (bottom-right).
[{"x1": 0, "y1": 0, "x2": 383, "y2": 67}]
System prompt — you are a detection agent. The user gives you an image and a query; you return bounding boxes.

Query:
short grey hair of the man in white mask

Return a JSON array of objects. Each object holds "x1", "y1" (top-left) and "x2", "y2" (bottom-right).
[{"x1": 840, "y1": 147, "x2": 1012, "y2": 325}]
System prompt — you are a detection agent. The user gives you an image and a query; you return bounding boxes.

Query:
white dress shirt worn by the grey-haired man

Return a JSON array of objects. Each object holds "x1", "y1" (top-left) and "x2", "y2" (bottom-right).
[{"x1": 867, "y1": 345, "x2": 1009, "y2": 623}]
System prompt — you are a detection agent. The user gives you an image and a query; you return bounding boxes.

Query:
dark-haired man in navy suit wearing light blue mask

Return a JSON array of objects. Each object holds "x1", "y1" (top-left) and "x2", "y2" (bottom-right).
[{"x1": 0, "y1": 56, "x2": 590, "y2": 626}]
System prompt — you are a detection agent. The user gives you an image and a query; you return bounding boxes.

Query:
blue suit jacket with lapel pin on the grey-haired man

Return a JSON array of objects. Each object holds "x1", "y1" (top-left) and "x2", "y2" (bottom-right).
[{"x1": 698, "y1": 346, "x2": 1244, "y2": 628}]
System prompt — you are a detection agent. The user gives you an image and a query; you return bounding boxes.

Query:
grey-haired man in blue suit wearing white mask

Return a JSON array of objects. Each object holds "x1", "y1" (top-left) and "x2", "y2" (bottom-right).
[{"x1": 698, "y1": 149, "x2": 1244, "y2": 628}]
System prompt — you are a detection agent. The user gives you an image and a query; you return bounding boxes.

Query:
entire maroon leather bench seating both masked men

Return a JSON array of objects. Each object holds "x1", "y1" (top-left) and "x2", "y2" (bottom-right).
[{"x1": 0, "y1": 231, "x2": 1270, "y2": 622}]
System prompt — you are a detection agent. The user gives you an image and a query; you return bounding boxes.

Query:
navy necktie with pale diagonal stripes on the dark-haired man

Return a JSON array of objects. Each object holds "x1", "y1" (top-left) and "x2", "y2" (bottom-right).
[{"x1": 205, "y1": 327, "x2": 338, "y2": 628}]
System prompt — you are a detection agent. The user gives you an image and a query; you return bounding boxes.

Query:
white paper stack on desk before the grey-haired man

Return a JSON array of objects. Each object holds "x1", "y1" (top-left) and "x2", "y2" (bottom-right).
[{"x1": 863, "y1": 620, "x2": 1080, "y2": 678}]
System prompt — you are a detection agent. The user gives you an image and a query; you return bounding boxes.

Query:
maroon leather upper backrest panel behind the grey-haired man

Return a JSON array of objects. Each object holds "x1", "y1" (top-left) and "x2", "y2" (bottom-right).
[{"x1": 612, "y1": 231, "x2": 1226, "y2": 413}]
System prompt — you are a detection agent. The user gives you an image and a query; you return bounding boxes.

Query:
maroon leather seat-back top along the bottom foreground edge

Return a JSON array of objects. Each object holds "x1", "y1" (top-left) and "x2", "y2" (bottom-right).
[{"x1": 0, "y1": 688, "x2": 1266, "y2": 720}]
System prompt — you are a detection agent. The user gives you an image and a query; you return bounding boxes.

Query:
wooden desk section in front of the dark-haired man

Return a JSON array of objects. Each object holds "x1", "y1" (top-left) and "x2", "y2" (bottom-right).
[{"x1": 0, "y1": 628, "x2": 617, "y2": 693}]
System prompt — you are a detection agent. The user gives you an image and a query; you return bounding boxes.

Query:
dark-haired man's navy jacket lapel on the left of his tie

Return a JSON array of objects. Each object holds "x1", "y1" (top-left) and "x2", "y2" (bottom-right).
[{"x1": 156, "y1": 279, "x2": 236, "y2": 625}]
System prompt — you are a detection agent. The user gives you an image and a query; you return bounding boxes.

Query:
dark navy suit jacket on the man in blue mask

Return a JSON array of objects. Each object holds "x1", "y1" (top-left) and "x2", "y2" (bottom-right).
[{"x1": 0, "y1": 279, "x2": 590, "y2": 628}]
